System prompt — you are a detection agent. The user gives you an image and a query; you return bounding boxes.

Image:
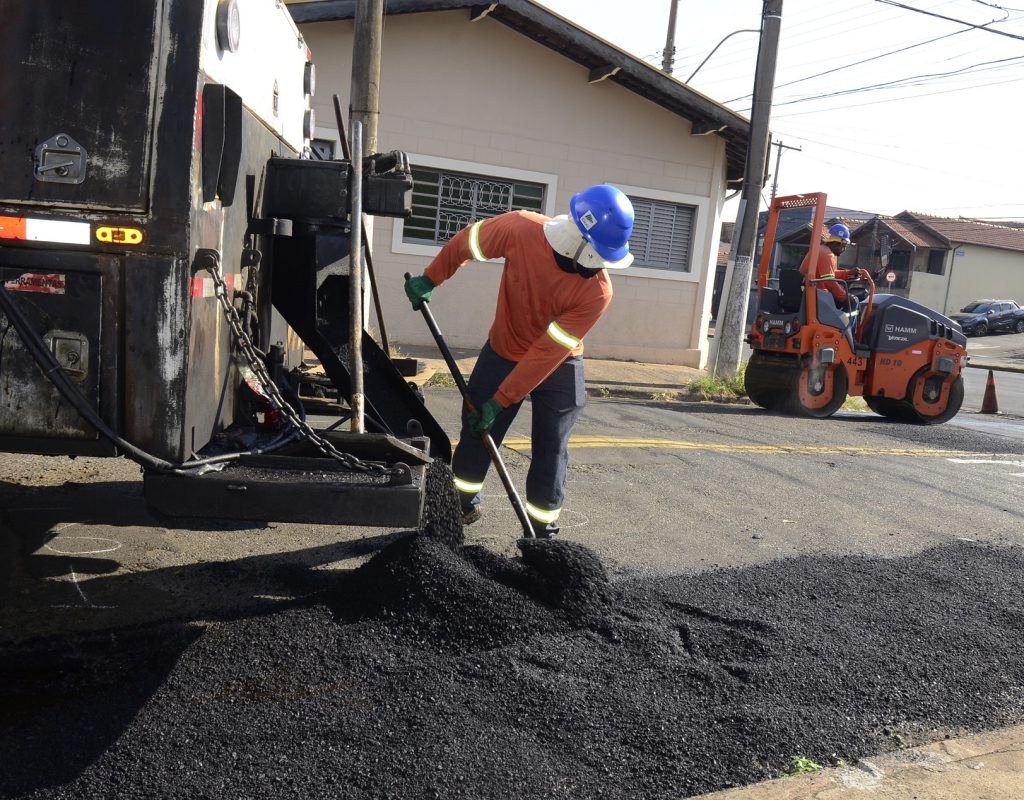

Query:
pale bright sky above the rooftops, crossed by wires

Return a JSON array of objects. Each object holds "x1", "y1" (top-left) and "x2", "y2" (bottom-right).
[{"x1": 536, "y1": 0, "x2": 1024, "y2": 221}]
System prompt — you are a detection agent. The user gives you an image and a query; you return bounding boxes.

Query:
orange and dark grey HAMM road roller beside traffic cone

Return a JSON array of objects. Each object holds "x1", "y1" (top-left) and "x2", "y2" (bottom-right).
[{"x1": 744, "y1": 193, "x2": 968, "y2": 424}]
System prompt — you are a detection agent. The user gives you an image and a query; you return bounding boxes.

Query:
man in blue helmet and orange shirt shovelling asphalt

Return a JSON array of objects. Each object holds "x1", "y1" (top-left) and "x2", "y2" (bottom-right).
[{"x1": 406, "y1": 184, "x2": 633, "y2": 539}]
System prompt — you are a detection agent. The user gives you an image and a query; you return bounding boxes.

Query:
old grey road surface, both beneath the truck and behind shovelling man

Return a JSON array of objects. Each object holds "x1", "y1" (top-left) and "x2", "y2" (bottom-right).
[{"x1": 0, "y1": 388, "x2": 1024, "y2": 640}]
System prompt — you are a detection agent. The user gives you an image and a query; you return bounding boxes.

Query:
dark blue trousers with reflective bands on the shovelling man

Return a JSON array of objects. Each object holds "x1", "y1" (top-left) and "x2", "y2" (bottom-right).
[{"x1": 452, "y1": 342, "x2": 587, "y2": 536}]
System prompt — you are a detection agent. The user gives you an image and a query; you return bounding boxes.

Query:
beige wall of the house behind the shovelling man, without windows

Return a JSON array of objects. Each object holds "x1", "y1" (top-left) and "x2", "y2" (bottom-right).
[{"x1": 302, "y1": 10, "x2": 725, "y2": 367}]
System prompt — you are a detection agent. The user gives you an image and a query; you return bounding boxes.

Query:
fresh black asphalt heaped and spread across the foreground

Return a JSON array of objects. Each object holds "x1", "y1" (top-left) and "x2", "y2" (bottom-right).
[{"x1": 0, "y1": 534, "x2": 1024, "y2": 799}]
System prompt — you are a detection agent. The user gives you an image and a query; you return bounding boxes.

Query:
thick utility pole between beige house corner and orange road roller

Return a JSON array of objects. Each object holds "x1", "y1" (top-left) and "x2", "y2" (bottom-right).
[{"x1": 714, "y1": 0, "x2": 782, "y2": 378}]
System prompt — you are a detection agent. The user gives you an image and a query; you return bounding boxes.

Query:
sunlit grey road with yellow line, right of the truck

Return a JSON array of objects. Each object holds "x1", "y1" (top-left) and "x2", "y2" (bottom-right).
[{"x1": 430, "y1": 393, "x2": 1024, "y2": 573}]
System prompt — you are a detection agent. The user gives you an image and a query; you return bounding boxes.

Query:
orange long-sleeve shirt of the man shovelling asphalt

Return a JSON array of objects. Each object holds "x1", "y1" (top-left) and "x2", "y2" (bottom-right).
[{"x1": 424, "y1": 211, "x2": 611, "y2": 407}]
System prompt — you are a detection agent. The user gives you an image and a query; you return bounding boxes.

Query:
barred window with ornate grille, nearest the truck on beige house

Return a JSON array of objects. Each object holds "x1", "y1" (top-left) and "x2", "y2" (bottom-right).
[{"x1": 402, "y1": 167, "x2": 545, "y2": 245}]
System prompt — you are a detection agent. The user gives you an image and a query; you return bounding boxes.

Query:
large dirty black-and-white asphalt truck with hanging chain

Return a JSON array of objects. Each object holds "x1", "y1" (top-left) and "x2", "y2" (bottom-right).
[{"x1": 0, "y1": 0, "x2": 451, "y2": 525}]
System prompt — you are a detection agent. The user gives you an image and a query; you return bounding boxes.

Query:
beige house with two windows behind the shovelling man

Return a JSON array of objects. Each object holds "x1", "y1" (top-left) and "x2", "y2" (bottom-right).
[{"x1": 289, "y1": 0, "x2": 750, "y2": 367}]
